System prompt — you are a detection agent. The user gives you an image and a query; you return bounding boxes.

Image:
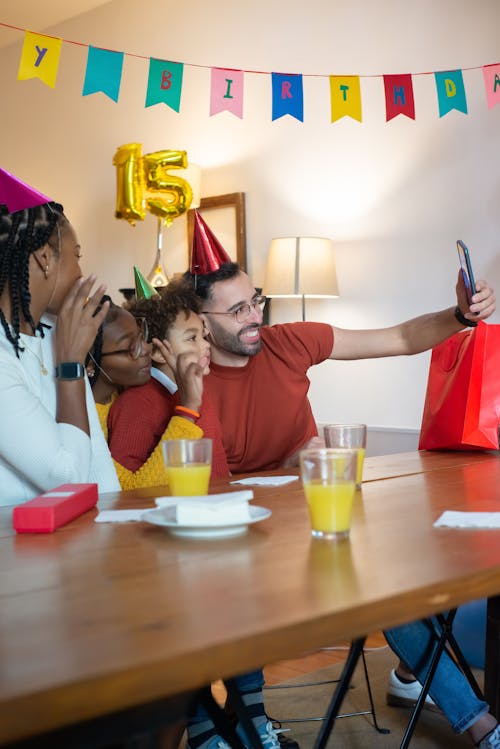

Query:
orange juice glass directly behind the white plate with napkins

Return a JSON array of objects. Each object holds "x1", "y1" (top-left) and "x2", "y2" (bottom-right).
[{"x1": 162, "y1": 438, "x2": 212, "y2": 497}]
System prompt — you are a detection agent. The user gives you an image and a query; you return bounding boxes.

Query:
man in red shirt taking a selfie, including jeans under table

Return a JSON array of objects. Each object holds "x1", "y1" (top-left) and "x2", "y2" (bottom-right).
[{"x1": 186, "y1": 207, "x2": 500, "y2": 749}]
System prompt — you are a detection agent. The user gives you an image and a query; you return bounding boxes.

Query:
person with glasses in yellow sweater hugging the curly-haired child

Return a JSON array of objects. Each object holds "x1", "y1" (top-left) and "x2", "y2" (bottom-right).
[{"x1": 86, "y1": 301, "x2": 203, "y2": 489}]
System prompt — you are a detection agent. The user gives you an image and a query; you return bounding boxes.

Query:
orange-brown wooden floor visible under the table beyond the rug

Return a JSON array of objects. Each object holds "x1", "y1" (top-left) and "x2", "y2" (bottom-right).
[{"x1": 213, "y1": 632, "x2": 388, "y2": 703}]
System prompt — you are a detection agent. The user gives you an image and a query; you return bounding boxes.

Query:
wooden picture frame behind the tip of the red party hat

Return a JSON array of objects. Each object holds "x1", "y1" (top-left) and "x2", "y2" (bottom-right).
[{"x1": 187, "y1": 192, "x2": 247, "y2": 272}]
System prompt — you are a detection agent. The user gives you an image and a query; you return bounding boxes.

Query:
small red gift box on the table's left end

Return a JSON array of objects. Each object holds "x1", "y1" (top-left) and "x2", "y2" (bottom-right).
[{"x1": 12, "y1": 484, "x2": 98, "y2": 533}]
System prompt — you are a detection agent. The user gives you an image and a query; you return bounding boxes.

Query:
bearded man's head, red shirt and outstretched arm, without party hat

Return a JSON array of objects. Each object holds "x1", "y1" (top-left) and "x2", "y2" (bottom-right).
[{"x1": 193, "y1": 263, "x2": 495, "y2": 473}]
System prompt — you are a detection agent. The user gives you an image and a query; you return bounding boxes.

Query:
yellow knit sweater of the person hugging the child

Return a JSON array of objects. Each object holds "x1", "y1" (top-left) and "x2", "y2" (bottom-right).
[{"x1": 96, "y1": 396, "x2": 203, "y2": 489}]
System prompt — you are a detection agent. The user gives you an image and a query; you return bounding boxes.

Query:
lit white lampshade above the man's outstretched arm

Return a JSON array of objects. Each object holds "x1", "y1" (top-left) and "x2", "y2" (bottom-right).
[{"x1": 262, "y1": 237, "x2": 339, "y2": 297}]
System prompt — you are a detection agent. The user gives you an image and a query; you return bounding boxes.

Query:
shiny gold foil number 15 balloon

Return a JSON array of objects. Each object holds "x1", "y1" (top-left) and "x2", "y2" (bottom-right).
[{"x1": 113, "y1": 143, "x2": 193, "y2": 225}]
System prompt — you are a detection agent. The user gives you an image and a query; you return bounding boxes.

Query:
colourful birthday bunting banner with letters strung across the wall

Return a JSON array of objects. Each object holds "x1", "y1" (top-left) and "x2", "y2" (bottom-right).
[{"x1": 0, "y1": 23, "x2": 500, "y2": 123}]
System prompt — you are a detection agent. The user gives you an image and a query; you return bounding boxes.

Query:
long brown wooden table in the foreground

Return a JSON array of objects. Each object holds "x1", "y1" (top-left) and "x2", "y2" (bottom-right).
[{"x1": 0, "y1": 453, "x2": 500, "y2": 744}]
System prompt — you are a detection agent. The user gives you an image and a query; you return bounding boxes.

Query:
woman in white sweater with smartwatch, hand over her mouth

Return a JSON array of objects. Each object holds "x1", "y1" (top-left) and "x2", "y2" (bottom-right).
[{"x1": 0, "y1": 170, "x2": 120, "y2": 506}]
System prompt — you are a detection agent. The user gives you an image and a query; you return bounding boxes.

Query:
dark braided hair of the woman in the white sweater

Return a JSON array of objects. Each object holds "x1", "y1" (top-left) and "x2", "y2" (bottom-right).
[{"x1": 0, "y1": 202, "x2": 67, "y2": 357}]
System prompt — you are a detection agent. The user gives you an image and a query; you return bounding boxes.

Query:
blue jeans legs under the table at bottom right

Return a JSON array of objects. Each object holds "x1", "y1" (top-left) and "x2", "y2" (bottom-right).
[{"x1": 384, "y1": 620, "x2": 489, "y2": 733}]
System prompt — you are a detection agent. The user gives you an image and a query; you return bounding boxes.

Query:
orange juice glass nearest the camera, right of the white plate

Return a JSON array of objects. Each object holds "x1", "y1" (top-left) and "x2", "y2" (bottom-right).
[{"x1": 300, "y1": 447, "x2": 358, "y2": 541}]
